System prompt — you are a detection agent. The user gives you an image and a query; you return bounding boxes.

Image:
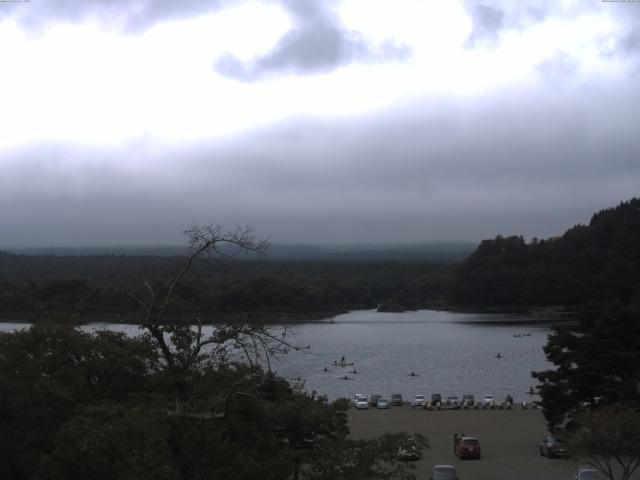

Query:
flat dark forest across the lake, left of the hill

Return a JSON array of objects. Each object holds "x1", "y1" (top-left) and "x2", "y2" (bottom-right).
[{"x1": 0, "y1": 252, "x2": 453, "y2": 320}]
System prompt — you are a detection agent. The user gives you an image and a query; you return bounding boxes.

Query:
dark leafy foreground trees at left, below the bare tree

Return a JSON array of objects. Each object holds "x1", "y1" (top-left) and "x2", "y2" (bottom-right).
[{"x1": 0, "y1": 325, "x2": 356, "y2": 480}]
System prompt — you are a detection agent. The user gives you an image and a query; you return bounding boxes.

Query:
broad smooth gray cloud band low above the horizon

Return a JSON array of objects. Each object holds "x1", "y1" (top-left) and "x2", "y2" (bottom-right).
[{"x1": 0, "y1": 82, "x2": 640, "y2": 246}]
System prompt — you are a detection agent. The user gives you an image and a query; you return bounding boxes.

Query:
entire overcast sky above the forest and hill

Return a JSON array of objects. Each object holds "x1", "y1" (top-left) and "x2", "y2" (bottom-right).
[{"x1": 0, "y1": 0, "x2": 640, "y2": 247}]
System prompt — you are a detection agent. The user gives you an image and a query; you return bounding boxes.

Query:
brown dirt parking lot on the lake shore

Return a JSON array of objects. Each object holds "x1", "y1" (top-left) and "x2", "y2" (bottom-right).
[{"x1": 349, "y1": 406, "x2": 576, "y2": 480}]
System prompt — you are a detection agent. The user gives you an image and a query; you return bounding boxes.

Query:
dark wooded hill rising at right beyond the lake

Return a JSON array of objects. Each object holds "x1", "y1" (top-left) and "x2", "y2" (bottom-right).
[{"x1": 453, "y1": 198, "x2": 640, "y2": 306}]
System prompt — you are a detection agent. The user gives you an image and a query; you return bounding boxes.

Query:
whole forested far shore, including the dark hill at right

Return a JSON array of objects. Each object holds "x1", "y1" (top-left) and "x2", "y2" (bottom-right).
[{"x1": 0, "y1": 199, "x2": 640, "y2": 320}]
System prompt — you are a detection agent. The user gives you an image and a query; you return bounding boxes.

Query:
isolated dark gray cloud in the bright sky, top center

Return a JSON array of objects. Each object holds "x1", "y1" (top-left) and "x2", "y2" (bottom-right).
[{"x1": 214, "y1": 0, "x2": 411, "y2": 82}]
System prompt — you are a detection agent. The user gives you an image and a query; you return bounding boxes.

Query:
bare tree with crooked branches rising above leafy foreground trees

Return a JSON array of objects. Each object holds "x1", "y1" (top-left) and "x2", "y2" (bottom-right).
[{"x1": 100, "y1": 225, "x2": 297, "y2": 372}]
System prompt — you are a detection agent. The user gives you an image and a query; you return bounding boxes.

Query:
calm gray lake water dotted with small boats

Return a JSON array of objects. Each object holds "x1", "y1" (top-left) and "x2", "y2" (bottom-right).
[{"x1": 0, "y1": 310, "x2": 550, "y2": 401}]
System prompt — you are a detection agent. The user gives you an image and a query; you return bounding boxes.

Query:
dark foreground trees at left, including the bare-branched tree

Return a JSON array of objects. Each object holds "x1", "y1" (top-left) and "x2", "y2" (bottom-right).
[{"x1": 0, "y1": 227, "x2": 424, "y2": 480}]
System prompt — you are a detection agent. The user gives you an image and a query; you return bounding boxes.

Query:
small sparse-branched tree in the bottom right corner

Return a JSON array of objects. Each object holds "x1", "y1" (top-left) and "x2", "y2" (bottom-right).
[{"x1": 569, "y1": 407, "x2": 640, "y2": 480}]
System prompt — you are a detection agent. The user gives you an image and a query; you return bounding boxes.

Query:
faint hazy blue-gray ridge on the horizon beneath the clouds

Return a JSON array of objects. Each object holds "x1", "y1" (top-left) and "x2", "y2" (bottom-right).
[{"x1": 8, "y1": 242, "x2": 475, "y2": 263}]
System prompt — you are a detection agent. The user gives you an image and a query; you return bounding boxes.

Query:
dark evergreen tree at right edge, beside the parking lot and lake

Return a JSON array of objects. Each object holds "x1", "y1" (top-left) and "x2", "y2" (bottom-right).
[{"x1": 533, "y1": 303, "x2": 640, "y2": 429}]
